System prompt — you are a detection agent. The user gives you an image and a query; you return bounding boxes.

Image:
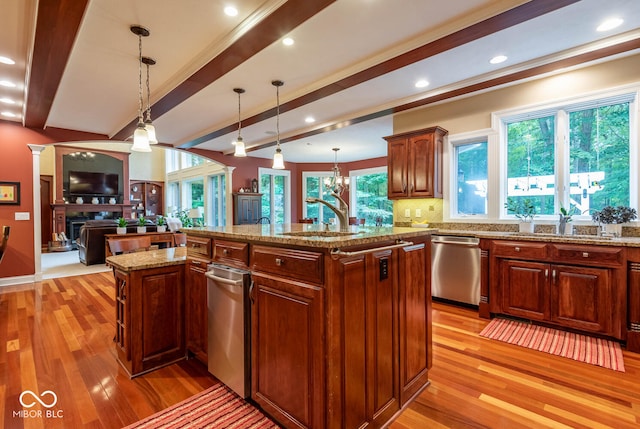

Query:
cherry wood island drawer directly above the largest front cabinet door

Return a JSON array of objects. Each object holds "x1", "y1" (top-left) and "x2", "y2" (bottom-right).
[{"x1": 251, "y1": 246, "x2": 322, "y2": 283}]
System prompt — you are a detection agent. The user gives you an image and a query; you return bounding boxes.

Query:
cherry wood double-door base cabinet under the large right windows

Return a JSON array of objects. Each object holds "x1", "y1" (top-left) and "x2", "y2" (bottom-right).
[{"x1": 491, "y1": 241, "x2": 626, "y2": 340}]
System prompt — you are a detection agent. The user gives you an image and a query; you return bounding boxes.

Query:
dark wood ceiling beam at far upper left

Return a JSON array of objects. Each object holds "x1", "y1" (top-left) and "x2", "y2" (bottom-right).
[{"x1": 23, "y1": 0, "x2": 89, "y2": 129}]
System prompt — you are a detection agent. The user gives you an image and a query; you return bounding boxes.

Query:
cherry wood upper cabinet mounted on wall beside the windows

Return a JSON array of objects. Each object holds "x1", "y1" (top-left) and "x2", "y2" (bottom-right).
[{"x1": 384, "y1": 127, "x2": 448, "y2": 199}]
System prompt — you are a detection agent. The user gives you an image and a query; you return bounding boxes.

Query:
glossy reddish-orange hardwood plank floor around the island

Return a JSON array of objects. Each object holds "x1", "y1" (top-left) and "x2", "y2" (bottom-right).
[{"x1": 0, "y1": 273, "x2": 640, "y2": 429}]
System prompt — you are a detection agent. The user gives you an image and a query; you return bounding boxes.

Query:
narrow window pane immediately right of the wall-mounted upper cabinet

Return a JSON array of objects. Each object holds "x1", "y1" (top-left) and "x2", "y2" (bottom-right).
[{"x1": 452, "y1": 140, "x2": 489, "y2": 216}]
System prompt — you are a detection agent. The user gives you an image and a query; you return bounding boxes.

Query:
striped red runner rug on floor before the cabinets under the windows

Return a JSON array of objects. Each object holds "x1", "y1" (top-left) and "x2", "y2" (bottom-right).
[{"x1": 480, "y1": 317, "x2": 624, "y2": 372}]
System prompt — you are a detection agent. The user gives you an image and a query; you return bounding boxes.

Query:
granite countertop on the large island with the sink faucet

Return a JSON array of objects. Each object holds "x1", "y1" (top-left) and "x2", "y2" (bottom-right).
[{"x1": 181, "y1": 223, "x2": 436, "y2": 249}]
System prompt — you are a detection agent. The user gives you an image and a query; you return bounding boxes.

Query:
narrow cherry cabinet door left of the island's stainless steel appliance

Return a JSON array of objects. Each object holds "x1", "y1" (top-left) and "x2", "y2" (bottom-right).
[{"x1": 184, "y1": 259, "x2": 208, "y2": 365}]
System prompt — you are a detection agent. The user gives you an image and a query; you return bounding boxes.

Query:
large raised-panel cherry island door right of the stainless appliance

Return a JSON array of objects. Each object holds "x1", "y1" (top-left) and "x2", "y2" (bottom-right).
[{"x1": 251, "y1": 274, "x2": 325, "y2": 428}]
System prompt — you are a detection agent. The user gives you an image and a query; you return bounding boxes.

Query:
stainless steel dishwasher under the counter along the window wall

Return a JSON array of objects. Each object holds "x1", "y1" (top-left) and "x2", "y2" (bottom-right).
[{"x1": 431, "y1": 235, "x2": 480, "y2": 305}]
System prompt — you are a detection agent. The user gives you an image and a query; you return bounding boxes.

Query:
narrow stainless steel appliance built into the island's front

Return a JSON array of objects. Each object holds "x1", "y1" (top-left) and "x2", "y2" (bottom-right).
[{"x1": 205, "y1": 264, "x2": 251, "y2": 398}]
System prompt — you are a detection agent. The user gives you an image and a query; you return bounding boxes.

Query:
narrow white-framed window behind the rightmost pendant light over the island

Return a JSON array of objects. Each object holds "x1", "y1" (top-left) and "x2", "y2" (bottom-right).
[{"x1": 258, "y1": 168, "x2": 291, "y2": 224}]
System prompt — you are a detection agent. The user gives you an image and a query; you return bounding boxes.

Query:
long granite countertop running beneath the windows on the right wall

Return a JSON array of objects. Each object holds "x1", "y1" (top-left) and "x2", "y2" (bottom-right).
[{"x1": 432, "y1": 229, "x2": 640, "y2": 247}]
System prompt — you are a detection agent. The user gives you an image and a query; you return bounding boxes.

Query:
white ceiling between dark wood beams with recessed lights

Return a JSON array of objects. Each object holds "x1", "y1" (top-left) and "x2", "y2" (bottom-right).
[{"x1": 0, "y1": 0, "x2": 640, "y2": 162}]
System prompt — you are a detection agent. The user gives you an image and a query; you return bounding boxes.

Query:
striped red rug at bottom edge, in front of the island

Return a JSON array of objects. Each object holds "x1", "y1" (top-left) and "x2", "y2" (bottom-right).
[{"x1": 125, "y1": 384, "x2": 280, "y2": 429}]
